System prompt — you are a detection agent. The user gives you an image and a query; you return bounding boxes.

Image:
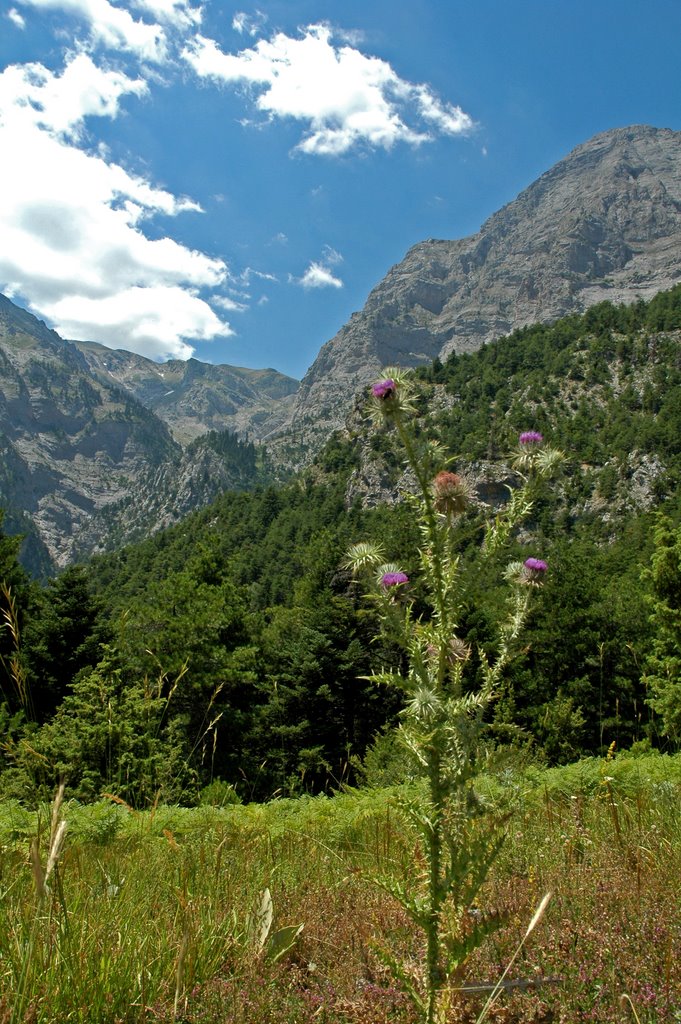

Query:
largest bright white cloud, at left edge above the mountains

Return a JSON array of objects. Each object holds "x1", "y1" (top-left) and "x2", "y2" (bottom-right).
[{"x1": 0, "y1": 54, "x2": 231, "y2": 358}]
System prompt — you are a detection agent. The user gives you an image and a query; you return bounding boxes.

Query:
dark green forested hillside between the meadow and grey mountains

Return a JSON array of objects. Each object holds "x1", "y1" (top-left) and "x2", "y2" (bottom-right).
[{"x1": 0, "y1": 288, "x2": 681, "y2": 805}]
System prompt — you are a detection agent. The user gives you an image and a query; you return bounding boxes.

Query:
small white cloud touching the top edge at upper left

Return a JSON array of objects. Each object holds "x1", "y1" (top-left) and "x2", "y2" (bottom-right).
[{"x1": 19, "y1": 0, "x2": 167, "y2": 61}]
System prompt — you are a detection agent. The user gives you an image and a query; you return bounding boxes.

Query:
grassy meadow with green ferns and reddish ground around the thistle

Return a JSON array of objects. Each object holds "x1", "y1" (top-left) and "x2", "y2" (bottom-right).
[{"x1": 0, "y1": 756, "x2": 681, "y2": 1024}]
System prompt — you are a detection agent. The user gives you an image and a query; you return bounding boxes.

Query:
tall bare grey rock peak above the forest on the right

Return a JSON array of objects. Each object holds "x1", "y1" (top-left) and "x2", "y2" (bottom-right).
[{"x1": 274, "y1": 126, "x2": 681, "y2": 458}]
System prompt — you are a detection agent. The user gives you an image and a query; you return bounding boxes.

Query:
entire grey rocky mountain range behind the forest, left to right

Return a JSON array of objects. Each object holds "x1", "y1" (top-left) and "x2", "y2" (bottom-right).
[{"x1": 0, "y1": 120, "x2": 681, "y2": 571}]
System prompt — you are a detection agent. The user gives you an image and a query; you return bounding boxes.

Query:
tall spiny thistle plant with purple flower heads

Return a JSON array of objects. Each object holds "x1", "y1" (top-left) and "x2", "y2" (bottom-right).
[{"x1": 347, "y1": 370, "x2": 561, "y2": 1024}]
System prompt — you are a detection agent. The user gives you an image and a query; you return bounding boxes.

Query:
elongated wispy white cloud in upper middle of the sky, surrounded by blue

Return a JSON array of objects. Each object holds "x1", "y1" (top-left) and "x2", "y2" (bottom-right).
[{"x1": 182, "y1": 25, "x2": 473, "y2": 156}]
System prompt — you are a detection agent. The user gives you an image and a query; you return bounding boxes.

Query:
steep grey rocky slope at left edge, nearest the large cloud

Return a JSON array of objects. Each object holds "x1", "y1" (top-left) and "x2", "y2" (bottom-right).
[{"x1": 0, "y1": 297, "x2": 179, "y2": 564}]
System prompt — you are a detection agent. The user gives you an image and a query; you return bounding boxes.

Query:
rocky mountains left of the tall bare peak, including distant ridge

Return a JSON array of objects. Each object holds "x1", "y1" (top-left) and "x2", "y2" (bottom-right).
[{"x1": 0, "y1": 296, "x2": 296, "y2": 574}]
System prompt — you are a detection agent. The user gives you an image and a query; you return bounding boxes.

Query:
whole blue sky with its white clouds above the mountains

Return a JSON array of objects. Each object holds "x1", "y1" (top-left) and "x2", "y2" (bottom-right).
[{"x1": 0, "y1": 0, "x2": 681, "y2": 377}]
